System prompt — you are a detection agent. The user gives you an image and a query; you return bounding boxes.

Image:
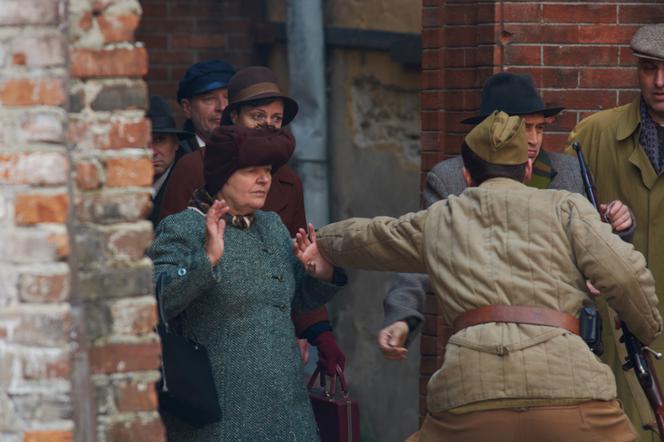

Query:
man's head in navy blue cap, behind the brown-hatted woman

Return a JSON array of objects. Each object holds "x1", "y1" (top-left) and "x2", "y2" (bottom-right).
[{"x1": 177, "y1": 60, "x2": 235, "y2": 152}]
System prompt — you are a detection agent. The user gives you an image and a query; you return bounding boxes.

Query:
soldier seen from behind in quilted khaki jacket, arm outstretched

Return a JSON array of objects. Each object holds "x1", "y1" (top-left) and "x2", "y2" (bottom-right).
[{"x1": 296, "y1": 111, "x2": 662, "y2": 442}]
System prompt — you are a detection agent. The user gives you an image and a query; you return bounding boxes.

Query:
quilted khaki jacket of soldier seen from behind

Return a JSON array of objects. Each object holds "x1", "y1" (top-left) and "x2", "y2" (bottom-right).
[{"x1": 318, "y1": 178, "x2": 662, "y2": 412}]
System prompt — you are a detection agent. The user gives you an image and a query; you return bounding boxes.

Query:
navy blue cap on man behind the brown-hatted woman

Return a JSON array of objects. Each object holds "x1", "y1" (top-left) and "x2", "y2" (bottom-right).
[{"x1": 177, "y1": 60, "x2": 235, "y2": 102}]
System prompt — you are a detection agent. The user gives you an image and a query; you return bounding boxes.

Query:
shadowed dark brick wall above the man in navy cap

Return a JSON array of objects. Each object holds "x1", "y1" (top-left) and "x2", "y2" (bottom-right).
[{"x1": 138, "y1": 0, "x2": 266, "y2": 119}]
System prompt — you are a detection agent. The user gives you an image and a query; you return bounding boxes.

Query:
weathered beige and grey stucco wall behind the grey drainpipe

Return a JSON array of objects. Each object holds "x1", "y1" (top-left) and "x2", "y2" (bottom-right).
[{"x1": 269, "y1": 0, "x2": 421, "y2": 442}]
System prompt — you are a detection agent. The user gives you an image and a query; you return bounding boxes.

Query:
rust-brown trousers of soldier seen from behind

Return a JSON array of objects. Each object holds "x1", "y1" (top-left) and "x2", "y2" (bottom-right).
[{"x1": 406, "y1": 401, "x2": 638, "y2": 442}]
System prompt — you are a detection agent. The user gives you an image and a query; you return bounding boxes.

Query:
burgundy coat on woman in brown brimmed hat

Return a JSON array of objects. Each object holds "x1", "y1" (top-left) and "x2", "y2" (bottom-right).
[{"x1": 157, "y1": 147, "x2": 329, "y2": 336}]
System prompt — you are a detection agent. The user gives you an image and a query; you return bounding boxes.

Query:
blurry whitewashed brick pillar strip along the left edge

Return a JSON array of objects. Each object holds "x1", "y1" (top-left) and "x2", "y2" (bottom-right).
[{"x1": 0, "y1": 0, "x2": 73, "y2": 442}]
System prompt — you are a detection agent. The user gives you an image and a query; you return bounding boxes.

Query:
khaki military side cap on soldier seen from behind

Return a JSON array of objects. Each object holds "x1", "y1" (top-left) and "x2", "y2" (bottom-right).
[{"x1": 465, "y1": 111, "x2": 528, "y2": 166}]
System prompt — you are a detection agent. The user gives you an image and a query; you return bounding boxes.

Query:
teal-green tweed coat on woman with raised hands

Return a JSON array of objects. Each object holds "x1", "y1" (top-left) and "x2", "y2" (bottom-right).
[{"x1": 148, "y1": 208, "x2": 340, "y2": 442}]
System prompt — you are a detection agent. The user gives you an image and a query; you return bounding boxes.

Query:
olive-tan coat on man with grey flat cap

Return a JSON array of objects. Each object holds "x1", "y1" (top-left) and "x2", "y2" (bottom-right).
[{"x1": 569, "y1": 97, "x2": 664, "y2": 440}]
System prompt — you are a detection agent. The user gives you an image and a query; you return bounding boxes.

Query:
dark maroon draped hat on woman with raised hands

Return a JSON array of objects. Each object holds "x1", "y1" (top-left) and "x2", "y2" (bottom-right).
[{"x1": 203, "y1": 126, "x2": 295, "y2": 196}]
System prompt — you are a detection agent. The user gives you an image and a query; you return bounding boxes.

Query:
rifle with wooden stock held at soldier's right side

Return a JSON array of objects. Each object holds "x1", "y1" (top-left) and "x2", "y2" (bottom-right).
[{"x1": 572, "y1": 141, "x2": 664, "y2": 442}]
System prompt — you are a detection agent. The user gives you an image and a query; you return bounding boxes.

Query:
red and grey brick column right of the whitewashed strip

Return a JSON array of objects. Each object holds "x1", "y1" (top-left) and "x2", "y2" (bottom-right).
[{"x1": 68, "y1": 0, "x2": 164, "y2": 442}]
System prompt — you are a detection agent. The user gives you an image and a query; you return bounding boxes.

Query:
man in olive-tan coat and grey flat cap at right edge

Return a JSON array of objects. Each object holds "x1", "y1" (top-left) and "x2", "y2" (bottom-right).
[{"x1": 569, "y1": 23, "x2": 664, "y2": 441}]
